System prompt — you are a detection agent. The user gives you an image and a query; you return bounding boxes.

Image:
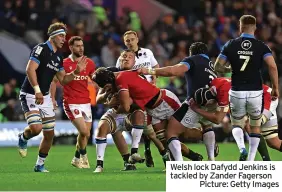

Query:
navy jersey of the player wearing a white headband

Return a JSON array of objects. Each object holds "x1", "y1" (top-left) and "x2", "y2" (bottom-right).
[{"x1": 21, "y1": 41, "x2": 64, "y2": 95}]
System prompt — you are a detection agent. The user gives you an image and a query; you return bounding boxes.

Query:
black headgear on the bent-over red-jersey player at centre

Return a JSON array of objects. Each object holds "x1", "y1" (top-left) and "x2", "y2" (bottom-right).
[{"x1": 92, "y1": 67, "x2": 116, "y2": 88}]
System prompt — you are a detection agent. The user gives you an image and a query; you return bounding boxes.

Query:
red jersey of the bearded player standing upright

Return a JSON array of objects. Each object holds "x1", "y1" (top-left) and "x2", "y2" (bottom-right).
[{"x1": 63, "y1": 57, "x2": 95, "y2": 104}]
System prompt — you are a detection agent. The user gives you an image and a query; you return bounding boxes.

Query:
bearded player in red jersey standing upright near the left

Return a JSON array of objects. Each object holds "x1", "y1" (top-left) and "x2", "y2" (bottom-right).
[{"x1": 53, "y1": 36, "x2": 95, "y2": 168}]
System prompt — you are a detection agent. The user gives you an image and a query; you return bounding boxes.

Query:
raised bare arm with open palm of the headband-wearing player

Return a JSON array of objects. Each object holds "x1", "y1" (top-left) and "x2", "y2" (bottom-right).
[{"x1": 56, "y1": 56, "x2": 87, "y2": 86}]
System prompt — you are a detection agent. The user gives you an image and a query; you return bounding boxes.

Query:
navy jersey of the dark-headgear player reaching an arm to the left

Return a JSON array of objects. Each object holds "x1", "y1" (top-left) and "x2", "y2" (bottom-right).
[{"x1": 180, "y1": 54, "x2": 217, "y2": 99}]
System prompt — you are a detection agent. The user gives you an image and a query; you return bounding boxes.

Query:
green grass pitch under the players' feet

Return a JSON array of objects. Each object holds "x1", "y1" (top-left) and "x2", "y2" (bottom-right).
[{"x1": 0, "y1": 144, "x2": 282, "y2": 191}]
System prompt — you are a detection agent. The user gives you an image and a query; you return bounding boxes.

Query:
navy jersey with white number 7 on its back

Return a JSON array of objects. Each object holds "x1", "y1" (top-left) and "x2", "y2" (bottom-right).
[{"x1": 219, "y1": 34, "x2": 272, "y2": 91}]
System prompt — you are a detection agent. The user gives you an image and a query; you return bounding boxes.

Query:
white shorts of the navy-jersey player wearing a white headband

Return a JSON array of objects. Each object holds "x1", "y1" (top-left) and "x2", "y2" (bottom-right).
[{"x1": 19, "y1": 92, "x2": 55, "y2": 118}]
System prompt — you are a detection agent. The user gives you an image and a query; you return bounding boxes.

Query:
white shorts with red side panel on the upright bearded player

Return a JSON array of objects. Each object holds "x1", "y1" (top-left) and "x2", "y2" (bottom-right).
[{"x1": 63, "y1": 100, "x2": 92, "y2": 122}]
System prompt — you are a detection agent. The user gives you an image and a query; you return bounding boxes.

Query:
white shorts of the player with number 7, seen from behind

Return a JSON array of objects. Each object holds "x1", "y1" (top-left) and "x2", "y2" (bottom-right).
[{"x1": 229, "y1": 90, "x2": 263, "y2": 120}]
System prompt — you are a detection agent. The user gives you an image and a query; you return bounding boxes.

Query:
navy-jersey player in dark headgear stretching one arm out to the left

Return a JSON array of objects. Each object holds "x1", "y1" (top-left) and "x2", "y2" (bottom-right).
[{"x1": 139, "y1": 42, "x2": 216, "y2": 161}]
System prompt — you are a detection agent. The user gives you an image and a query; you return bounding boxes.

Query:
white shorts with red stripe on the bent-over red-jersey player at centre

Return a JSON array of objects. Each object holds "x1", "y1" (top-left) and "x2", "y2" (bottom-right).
[{"x1": 146, "y1": 89, "x2": 181, "y2": 125}]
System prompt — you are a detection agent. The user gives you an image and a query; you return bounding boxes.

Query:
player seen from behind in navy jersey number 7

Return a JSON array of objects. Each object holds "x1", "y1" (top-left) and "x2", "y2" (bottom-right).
[{"x1": 215, "y1": 15, "x2": 279, "y2": 161}]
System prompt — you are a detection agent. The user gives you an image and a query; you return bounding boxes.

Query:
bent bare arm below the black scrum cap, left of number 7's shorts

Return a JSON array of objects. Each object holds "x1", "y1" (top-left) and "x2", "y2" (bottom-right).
[{"x1": 190, "y1": 103, "x2": 227, "y2": 124}]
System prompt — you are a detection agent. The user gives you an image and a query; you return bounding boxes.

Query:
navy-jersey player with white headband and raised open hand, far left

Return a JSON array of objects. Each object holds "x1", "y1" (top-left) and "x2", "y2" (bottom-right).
[{"x1": 18, "y1": 23, "x2": 87, "y2": 172}]
